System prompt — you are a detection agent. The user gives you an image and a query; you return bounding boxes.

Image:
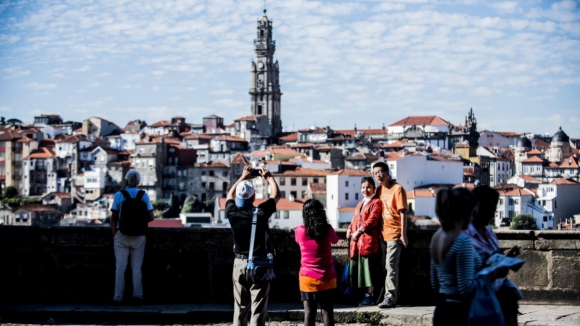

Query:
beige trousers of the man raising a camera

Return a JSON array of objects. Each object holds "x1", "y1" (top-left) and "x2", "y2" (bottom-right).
[{"x1": 232, "y1": 258, "x2": 270, "y2": 326}]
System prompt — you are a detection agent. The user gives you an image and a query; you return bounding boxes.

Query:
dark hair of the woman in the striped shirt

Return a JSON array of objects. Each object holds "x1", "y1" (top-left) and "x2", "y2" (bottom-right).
[{"x1": 435, "y1": 188, "x2": 477, "y2": 231}]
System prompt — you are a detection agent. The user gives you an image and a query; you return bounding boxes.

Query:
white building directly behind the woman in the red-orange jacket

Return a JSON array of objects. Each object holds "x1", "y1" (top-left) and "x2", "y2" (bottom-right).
[{"x1": 326, "y1": 170, "x2": 371, "y2": 229}]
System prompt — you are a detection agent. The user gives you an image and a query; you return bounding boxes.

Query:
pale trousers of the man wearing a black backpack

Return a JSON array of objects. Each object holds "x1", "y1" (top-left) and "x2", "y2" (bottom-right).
[{"x1": 113, "y1": 231, "x2": 145, "y2": 301}]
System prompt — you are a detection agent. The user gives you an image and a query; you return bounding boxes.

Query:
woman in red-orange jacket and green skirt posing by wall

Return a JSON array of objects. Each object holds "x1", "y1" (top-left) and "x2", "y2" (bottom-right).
[{"x1": 346, "y1": 177, "x2": 382, "y2": 307}]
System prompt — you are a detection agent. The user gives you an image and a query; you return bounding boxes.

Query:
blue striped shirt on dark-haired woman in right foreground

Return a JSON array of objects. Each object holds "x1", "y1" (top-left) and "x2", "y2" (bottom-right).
[{"x1": 431, "y1": 233, "x2": 481, "y2": 297}]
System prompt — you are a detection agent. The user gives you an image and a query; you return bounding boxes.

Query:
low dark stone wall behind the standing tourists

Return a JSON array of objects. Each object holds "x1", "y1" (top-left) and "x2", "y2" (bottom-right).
[{"x1": 0, "y1": 226, "x2": 580, "y2": 305}]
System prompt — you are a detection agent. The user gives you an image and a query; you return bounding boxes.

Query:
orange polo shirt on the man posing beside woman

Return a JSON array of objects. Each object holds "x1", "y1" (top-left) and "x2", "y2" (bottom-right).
[{"x1": 377, "y1": 183, "x2": 407, "y2": 241}]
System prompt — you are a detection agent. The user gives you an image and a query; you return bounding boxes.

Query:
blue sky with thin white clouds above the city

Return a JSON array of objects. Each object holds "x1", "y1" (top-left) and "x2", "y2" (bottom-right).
[{"x1": 0, "y1": 0, "x2": 580, "y2": 138}]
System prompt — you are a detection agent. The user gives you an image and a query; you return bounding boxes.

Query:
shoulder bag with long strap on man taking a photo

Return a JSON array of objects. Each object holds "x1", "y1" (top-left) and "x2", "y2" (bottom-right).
[{"x1": 246, "y1": 208, "x2": 276, "y2": 284}]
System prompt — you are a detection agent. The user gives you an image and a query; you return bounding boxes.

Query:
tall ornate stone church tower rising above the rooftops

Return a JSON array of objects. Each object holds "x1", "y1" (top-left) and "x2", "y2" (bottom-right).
[{"x1": 249, "y1": 10, "x2": 282, "y2": 137}]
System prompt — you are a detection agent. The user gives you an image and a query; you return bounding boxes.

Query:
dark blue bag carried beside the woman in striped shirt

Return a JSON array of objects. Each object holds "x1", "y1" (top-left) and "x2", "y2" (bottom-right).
[{"x1": 468, "y1": 277, "x2": 505, "y2": 326}]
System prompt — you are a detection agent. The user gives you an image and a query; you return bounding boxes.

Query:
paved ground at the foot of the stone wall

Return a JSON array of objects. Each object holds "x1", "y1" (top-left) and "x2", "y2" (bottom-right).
[{"x1": 0, "y1": 303, "x2": 580, "y2": 326}]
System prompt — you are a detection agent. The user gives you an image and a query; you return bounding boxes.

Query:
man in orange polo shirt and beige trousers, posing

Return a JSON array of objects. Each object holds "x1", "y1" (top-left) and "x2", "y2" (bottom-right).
[{"x1": 373, "y1": 162, "x2": 407, "y2": 308}]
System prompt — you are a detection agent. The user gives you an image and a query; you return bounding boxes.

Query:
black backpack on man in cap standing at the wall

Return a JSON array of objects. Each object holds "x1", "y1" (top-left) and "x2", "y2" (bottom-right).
[{"x1": 119, "y1": 190, "x2": 149, "y2": 235}]
